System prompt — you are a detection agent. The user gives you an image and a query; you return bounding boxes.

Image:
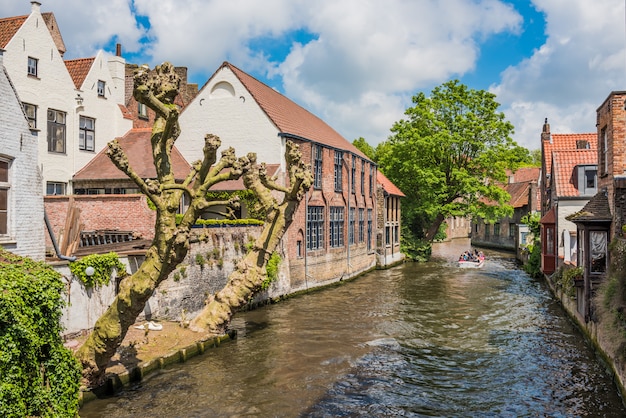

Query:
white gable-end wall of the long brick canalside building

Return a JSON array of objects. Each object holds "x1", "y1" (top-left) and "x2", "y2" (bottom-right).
[{"x1": 176, "y1": 67, "x2": 285, "y2": 172}]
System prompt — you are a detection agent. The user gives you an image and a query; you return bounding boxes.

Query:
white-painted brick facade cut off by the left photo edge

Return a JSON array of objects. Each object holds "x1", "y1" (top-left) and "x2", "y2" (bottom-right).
[{"x1": 0, "y1": 50, "x2": 45, "y2": 260}]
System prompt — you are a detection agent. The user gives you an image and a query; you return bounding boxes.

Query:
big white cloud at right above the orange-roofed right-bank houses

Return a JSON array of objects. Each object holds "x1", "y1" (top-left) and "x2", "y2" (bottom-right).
[{"x1": 492, "y1": 0, "x2": 626, "y2": 149}]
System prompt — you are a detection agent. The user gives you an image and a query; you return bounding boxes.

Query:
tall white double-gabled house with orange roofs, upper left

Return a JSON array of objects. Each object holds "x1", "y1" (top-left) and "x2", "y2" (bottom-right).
[{"x1": 0, "y1": 1, "x2": 132, "y2": 194}]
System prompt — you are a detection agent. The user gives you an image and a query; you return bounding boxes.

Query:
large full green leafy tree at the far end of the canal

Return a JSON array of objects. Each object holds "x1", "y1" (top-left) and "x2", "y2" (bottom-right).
[{"x1": 377, "y1": 80, "x2": 529, "y2": 241}]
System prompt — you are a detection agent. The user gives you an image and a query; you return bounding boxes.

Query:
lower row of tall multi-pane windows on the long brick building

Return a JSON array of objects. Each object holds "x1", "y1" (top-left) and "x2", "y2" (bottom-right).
[{"x1": 306, "y1": 206, "x2": 373, "y2": 251}]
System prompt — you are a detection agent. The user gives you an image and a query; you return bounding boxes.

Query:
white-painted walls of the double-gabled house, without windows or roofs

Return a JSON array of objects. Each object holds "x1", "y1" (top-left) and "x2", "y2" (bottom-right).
[{"x1": 4, "y1": 2, "x2": 132, "y2": 194}]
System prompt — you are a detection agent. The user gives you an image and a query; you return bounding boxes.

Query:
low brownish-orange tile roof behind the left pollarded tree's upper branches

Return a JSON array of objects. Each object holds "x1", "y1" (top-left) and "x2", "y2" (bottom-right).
[{"x1": 74, "y1": 128, "x2": 191, "y2": 180}]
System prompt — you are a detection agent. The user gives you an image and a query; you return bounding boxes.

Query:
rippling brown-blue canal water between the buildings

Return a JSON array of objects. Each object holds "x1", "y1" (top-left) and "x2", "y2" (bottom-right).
[{"x1": 80, "y1": 245, "x2": 626, "y2": 418}]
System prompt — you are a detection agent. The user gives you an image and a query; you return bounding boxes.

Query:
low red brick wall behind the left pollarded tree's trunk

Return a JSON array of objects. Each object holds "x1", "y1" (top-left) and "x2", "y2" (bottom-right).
[{"x1": 44, "y1": 194, "x2": 156, "y2": 248}]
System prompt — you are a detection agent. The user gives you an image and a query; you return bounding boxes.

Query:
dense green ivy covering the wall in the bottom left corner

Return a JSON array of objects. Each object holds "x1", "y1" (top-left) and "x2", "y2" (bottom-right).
[{"x1": 0, "y1": 249, "x2": 81, "y2": 417}]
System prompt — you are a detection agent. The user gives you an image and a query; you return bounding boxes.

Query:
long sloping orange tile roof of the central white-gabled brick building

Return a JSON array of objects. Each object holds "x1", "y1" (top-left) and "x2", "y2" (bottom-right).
[{"x1": 216, "y1": 62, "x2": 371, "y2": 161}]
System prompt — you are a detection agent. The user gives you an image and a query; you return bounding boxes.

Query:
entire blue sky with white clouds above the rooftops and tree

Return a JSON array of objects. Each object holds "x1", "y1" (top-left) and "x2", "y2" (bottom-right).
[{"x1": 0, "y1": 0, "x2": 626, "y2": 149}]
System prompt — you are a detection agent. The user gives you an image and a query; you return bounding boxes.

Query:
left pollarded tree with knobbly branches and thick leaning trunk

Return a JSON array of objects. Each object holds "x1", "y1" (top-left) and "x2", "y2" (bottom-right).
[{"x1": 76, "y1": 63, "x2": 310, "y2": 386}]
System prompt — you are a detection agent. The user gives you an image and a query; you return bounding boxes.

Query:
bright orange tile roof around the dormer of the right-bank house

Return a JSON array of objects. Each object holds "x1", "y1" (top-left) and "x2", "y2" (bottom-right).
[{"x1": 552, "y1": 149, "x2": 598, "y2": 197}]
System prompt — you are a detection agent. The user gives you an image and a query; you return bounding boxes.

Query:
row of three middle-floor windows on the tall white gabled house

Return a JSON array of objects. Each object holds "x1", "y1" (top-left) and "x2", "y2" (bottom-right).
[{"x1": 24, "y1": 103, "x2": 96, "y2": 154}]
